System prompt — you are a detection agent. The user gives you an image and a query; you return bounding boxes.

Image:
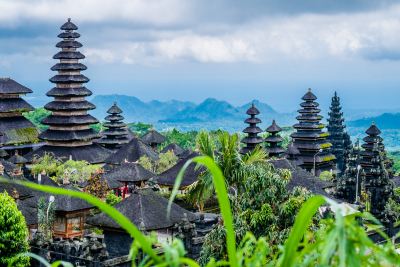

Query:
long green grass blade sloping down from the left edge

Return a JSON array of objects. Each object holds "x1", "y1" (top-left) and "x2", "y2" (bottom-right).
[{"x1": 0, "y1": 177, "x2": 161, "y2": 262}]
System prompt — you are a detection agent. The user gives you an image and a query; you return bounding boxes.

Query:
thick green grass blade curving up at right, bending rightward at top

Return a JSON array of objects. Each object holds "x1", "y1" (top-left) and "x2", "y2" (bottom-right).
[{"x1": 280, "y1": 196, "x2": 326, "y2": 267}]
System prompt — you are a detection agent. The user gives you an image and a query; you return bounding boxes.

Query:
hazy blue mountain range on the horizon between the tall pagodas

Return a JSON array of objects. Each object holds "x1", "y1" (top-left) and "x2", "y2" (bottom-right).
[{"x1": 91, "y1": 95, "x2": 295, "y2": 131}]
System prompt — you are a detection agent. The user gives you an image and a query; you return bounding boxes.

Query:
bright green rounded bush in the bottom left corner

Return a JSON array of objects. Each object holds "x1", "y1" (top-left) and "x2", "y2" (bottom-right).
[{"x1": 0, "y1": 192, "x2": 29, "y2": 266}]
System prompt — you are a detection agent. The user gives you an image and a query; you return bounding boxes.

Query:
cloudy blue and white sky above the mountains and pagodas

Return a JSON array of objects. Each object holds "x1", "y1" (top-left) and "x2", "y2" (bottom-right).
[{"x1": 0, "y1": 0, "x2": 400, "y2": 111}]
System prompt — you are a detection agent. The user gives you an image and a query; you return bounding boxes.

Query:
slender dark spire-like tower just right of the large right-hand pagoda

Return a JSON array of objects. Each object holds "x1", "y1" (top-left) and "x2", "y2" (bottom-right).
[{"x1": 327, "y1": 92, "x2": 351, "y2": 174}]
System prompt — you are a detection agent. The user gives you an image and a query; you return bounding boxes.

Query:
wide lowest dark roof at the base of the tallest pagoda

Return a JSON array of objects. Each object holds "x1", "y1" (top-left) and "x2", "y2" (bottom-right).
[{"x1": 25, "y1": 144, "x2": 111, "y2": 164}]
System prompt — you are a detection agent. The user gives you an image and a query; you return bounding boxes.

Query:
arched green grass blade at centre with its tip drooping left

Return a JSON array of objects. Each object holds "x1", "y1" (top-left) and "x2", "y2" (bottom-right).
[{"x1": 168, "y1": 156, "x2": 237, "y2": 267}]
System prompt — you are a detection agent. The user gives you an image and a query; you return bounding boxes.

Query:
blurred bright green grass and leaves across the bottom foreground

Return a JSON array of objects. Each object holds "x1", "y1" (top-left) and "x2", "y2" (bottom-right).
[{"x1": 0, "y1": 156, "x2": 400, "y2": 267}]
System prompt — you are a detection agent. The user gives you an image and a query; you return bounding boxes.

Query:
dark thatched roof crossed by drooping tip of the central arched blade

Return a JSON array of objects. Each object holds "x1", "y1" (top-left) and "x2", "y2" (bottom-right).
[{"x1": 155, "y1": 153, "x2": 204, "y2": 187}]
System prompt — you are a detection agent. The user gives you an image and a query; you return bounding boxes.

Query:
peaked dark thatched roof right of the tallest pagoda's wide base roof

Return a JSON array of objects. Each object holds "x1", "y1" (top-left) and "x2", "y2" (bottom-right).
[{"x1": 106, "y1": 137, "x2": 158, "y2": 165}]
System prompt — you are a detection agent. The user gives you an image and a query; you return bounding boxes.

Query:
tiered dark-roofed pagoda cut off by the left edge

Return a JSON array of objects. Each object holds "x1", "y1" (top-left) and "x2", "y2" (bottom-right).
[{"x1": 0, "y1": 78, "x2": 39, "y2": 155}]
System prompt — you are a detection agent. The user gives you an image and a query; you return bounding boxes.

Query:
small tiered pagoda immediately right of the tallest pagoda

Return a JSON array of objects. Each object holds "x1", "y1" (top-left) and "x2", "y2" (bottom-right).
[{"x1": 97, "y1": 102, "x2": 129, "y2": 150}]
